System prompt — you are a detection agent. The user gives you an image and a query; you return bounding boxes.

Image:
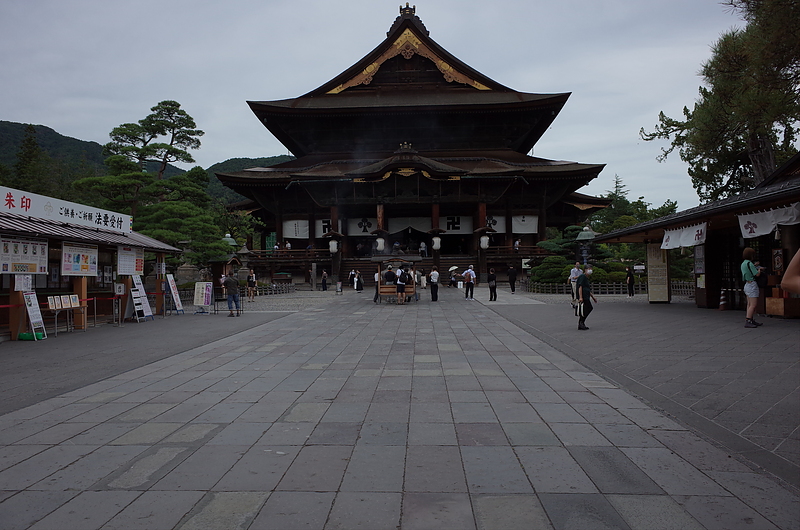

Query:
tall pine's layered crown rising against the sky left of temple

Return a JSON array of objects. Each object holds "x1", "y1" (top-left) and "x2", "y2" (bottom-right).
[{"x1": 104, "y1": 100, "x2": 205, "y2": 180}]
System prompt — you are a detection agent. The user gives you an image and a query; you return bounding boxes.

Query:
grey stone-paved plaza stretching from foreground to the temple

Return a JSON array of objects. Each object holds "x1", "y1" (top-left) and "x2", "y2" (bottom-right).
[{"x1": 0, "y1": 288, "x2": 800, "y2": 530}]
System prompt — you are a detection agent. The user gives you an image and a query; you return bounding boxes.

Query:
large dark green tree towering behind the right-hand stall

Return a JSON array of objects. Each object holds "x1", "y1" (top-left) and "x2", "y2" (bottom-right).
[{"x1": 640, "y1": 0, "x2": 800, "y2": 201}]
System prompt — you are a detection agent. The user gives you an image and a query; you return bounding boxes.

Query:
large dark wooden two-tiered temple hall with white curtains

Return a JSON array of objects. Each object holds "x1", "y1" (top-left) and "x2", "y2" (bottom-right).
[{"x1": 217, "y1": 4, "x2": 608, "y2": 273}]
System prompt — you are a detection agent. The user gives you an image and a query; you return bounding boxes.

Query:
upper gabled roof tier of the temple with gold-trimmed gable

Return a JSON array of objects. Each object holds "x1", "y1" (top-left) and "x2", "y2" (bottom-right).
[{"x1": 248, "y1": 6, "x2": 569, "y2": 157}]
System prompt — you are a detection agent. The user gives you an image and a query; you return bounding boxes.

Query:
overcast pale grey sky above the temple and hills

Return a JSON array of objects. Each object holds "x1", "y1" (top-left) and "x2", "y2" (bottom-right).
[{"x1": 0, "y1": 0, "x2": 743, "y2": 210}]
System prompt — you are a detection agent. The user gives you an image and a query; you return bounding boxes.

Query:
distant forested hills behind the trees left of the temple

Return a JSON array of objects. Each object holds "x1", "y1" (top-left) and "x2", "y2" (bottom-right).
[{"x1": 0, "y1": 120, "x2": 294, "y2": 203}]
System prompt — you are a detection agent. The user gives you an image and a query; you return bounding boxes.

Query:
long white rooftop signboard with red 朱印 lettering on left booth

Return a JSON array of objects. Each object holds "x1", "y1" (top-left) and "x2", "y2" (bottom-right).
[{"x1": 0, "y1": 186, "x2": 133, "y2": 233}]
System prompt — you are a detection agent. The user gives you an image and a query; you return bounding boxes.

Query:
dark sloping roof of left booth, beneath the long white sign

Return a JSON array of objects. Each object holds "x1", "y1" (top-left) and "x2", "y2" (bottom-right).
[{"x1": 0, "y1": 212, "x2": 181, "y2": 253}]
